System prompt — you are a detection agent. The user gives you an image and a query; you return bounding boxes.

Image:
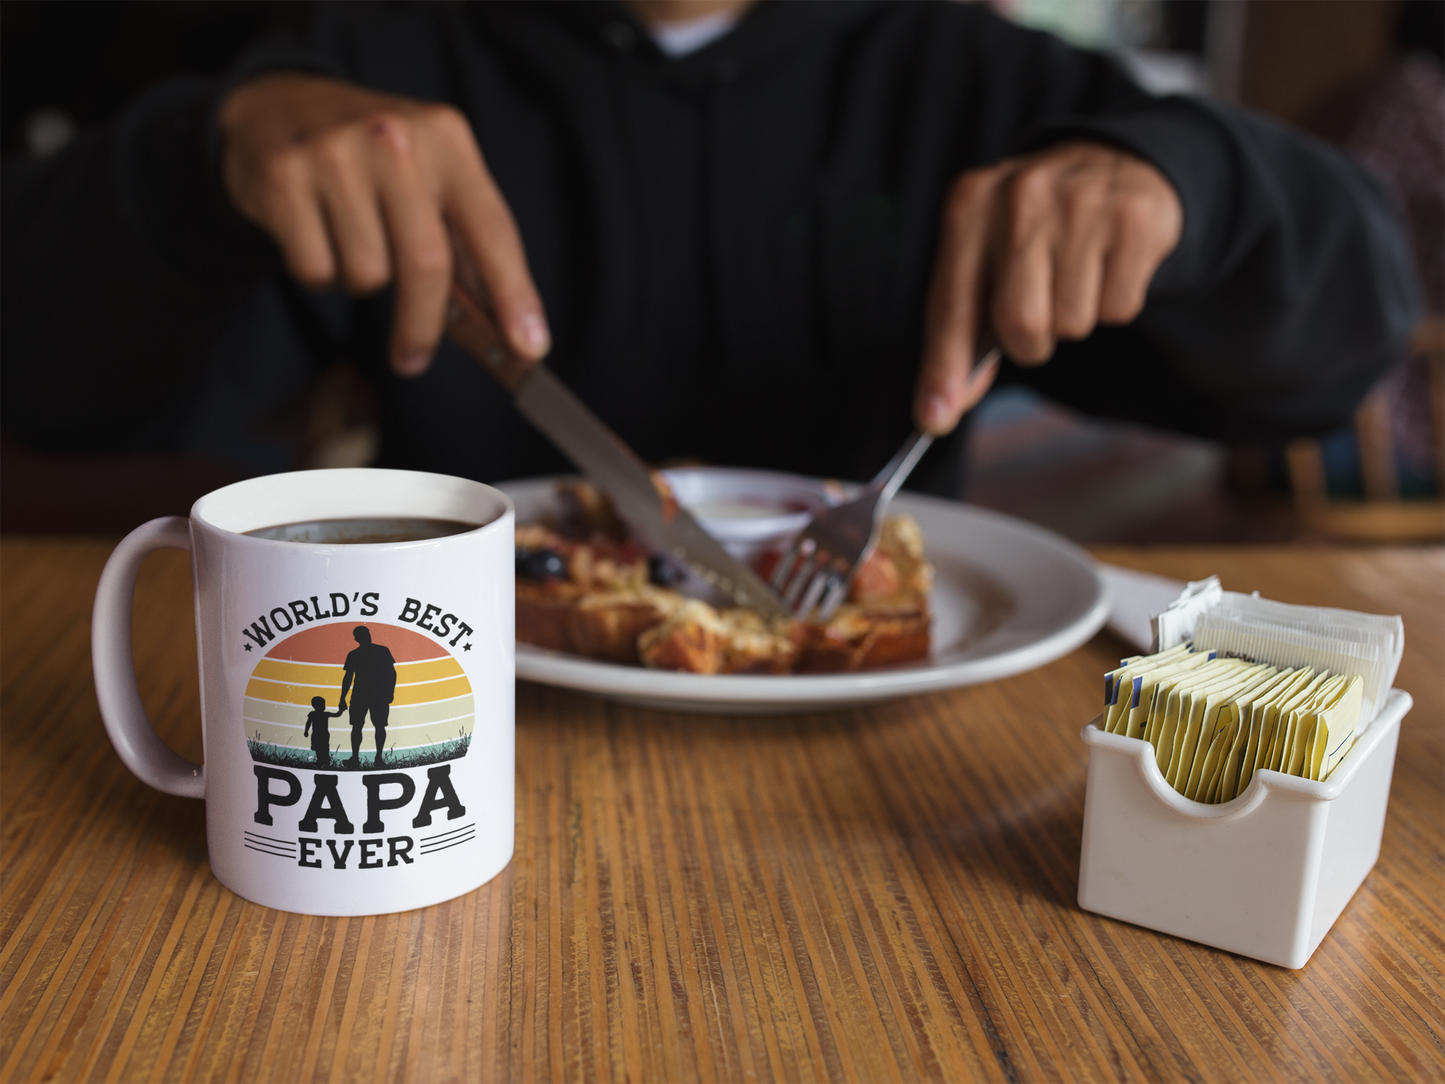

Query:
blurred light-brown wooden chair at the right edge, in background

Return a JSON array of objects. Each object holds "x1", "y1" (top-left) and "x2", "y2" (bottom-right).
[{"x1": 1285, "y1": 317, "x2": 1445, "y2": 542}]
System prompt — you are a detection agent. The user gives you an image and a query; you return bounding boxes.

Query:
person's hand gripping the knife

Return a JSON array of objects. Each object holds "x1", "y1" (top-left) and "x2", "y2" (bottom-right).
[{"x1": 220, "y1": 75, "x2": 551, "y2": 376}]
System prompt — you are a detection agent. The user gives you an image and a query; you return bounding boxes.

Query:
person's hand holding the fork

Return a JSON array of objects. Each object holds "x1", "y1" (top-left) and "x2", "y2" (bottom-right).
[{"x1": 913, "y1": 143, "x2": 1183, "y2": 435}]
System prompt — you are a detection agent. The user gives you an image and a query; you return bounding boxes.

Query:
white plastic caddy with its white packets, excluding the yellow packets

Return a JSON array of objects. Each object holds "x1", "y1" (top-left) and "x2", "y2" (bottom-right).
[{"x1": 1078, "y1": 577, "x2": 1412, "y2": 968}]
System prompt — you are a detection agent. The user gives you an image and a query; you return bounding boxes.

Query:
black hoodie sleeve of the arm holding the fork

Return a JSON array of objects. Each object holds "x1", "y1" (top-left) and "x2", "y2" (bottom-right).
[{"x1": 913, "y1": 3, "x2": 1422, "y2": 439}]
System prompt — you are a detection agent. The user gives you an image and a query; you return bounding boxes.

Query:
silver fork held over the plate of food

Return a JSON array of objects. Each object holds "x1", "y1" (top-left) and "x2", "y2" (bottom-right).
[{"x1": 772, "y1": 347, "x2": 1000, "y2": 621}]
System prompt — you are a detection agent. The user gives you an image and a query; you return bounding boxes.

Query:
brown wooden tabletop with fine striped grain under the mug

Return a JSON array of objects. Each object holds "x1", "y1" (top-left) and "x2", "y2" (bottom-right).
[{"x1": 0, "y1": 539, "x2": 1445, "y2": 1084}]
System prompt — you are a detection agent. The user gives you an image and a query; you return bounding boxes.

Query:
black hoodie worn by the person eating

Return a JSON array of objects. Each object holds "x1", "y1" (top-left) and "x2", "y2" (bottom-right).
[{"x1": 0, "y1": 0, "x2": 1419, "y2": 491}]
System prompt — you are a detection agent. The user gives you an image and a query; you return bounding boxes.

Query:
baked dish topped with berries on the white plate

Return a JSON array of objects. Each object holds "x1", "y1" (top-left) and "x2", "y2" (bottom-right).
[{"x1": 516, "y1": 481, "x2": 933, "y2": 674}]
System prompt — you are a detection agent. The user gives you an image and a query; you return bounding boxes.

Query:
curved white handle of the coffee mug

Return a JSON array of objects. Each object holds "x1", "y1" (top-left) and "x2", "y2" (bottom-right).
[{"x1": 91, "y1": 516, "x2": 205, "y2": 798}]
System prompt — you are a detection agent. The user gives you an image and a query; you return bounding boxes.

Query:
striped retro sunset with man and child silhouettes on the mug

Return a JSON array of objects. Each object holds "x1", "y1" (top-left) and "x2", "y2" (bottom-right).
[{"x1": 243, "y1": 620, "x2": 475, "y2": 772}]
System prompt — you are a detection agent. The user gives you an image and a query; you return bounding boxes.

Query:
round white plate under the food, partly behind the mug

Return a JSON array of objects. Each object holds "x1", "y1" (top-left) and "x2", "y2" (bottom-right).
[{"x1": 497, "y1": 478, "x2": 1108, "y2": 714}]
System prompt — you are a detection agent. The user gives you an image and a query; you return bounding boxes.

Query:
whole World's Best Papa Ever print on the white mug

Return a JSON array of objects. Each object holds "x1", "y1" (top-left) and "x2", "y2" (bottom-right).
[{"x1": 241, "y1": 607, "x2": 475, "y2": 870}]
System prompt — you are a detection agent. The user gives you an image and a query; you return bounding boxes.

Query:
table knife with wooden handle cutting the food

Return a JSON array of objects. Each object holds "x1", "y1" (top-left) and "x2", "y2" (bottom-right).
[{"x1": 447, "y1": 285, "x2": 792, "y2": 617}]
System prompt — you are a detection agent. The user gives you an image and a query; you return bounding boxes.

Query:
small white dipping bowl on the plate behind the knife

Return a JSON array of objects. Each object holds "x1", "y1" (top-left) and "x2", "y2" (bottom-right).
[{"x1": 662, "y1": 467, "x2": 844, "y2": 562}]
